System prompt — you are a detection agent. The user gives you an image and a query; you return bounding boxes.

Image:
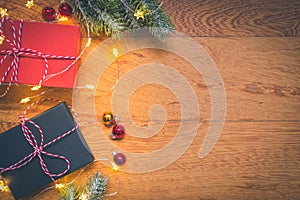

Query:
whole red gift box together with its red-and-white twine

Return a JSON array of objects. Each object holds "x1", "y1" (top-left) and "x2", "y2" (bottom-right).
[{"x1": 0, "y1": 20, "x2": 80, "y2": 88}]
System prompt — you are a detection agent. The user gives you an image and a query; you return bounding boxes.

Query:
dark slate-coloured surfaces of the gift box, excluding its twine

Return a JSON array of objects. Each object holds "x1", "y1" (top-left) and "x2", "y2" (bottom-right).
[{"x1": 0, "y1": 102, "x2": 94, "y2": 199}]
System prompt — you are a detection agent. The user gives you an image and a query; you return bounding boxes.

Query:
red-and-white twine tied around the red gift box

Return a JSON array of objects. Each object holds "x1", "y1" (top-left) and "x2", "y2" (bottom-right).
[{"x1": 0, "y1": 18, "x2": 77, "y2": 97}]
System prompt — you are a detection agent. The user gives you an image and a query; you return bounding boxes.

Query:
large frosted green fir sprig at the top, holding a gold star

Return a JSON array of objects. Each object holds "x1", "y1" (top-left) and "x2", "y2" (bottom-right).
[{"x1": 71, "y1": 0, "x2": 174, "y2": 40}]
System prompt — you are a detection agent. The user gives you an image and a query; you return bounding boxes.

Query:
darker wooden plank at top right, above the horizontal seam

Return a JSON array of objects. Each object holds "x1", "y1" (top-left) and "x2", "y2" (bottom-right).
[{"x1": 164, "y1": 0, "x2": 300, "y2": 37}]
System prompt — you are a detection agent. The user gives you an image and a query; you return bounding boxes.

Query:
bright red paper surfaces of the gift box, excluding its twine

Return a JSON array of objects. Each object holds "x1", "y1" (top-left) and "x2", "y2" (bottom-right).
[{"x1": 0, "y1": 21, "x2": 81, "y2": 88}]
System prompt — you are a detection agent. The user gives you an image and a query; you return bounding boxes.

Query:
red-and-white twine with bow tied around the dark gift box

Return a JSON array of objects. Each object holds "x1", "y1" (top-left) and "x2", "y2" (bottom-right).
[{"x1": 0, "y1": 99, "x2": 79, "y2": 181}]
